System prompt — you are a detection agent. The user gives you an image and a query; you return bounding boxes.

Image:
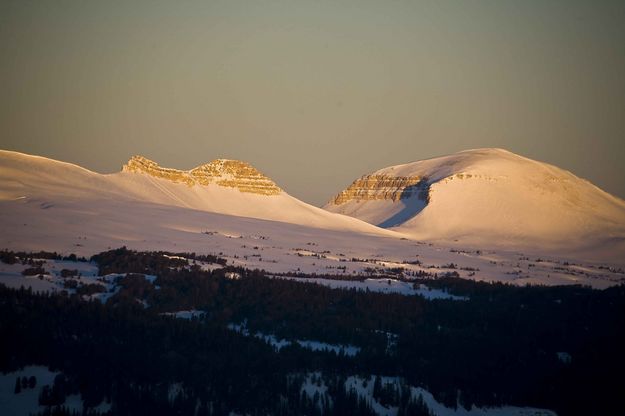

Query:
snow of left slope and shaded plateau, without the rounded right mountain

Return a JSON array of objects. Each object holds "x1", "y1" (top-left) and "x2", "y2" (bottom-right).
[{"x1": 0, "y1": 151, "x2": 625, "y2": 290}]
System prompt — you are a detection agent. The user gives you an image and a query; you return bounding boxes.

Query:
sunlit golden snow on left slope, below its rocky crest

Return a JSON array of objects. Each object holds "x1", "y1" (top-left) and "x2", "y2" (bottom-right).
[{"x1": 0, "y1": 150, "x2": 393, "y2": 235}]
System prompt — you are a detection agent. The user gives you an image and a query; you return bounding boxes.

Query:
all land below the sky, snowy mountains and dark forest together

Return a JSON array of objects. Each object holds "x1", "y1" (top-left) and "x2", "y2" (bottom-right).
[{"x1": 0, "y1": 149, "x2": 625, "y2": 416}]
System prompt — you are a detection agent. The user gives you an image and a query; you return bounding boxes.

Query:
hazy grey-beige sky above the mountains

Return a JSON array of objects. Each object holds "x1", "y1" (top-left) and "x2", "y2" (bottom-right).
[{"x1": 0, "y1": 0, "x2": 625, "y2": 205}]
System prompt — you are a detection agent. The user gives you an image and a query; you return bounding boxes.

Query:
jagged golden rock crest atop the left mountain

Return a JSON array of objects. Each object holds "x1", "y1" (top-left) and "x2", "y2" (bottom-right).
[{"x1": 122, "y1": 156, "x2": 282, "y2": 195}]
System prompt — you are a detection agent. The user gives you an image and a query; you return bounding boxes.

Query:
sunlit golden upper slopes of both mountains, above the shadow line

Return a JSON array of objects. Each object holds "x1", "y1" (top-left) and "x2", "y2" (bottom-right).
[{"x1": 0, "y1": 149, "x2": 625, "y2": 253}]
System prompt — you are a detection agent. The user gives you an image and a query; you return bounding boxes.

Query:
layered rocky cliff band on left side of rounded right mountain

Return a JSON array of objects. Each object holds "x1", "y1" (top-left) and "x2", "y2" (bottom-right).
[{"x1": 331, "y1": 175, "x2": 429, "y2": 205}]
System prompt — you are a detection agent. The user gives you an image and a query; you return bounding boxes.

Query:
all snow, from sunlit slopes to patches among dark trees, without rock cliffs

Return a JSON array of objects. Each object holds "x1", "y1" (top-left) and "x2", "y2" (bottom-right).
[{"x1": 0, "y1": 149, "x2": 625, "y2": 416}]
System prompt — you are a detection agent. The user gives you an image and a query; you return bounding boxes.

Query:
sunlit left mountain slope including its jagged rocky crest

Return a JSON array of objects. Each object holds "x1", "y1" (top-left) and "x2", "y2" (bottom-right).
[{"x1": 0, "y1": 151, "x2": 393, "y2": 235}]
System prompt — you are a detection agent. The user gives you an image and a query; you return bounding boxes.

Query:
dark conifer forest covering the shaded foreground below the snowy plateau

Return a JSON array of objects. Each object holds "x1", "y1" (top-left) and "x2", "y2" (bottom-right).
[{"x1": 0, "y1": 248, "x2": 625, "y2": 415}]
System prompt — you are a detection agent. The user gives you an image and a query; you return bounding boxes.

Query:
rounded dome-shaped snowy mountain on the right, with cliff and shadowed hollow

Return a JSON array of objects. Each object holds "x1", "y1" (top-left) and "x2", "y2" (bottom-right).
[{"x1": 324, "y1": 149, "x2": 625, "y2": 247}]
